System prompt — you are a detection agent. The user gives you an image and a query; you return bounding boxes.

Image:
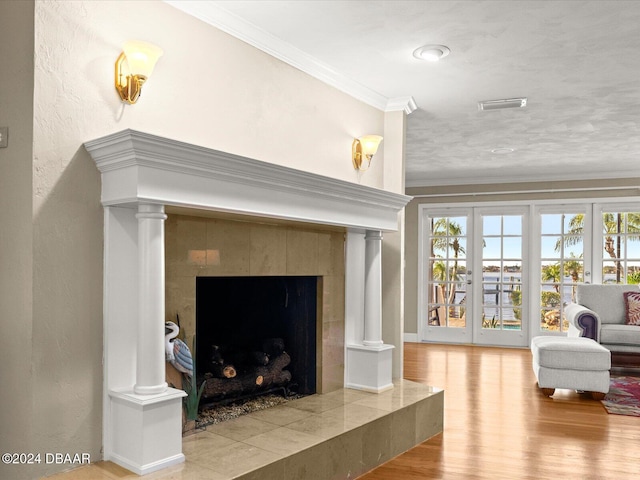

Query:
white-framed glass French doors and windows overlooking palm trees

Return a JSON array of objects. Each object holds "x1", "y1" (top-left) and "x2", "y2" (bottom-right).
[{"x1": 418, "y1": 199, "x2": 640, "y2": 346}]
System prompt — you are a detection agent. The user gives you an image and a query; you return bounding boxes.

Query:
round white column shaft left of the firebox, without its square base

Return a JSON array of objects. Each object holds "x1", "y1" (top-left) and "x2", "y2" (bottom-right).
[{"x1": 133, "y1": 204, "x2": 167, "y2": 395}]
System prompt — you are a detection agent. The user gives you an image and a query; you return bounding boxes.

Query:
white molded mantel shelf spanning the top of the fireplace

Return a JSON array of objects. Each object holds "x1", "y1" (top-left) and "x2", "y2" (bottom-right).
[{"x1": 85, "y1": 130, "x2": 411, "y2": 231}]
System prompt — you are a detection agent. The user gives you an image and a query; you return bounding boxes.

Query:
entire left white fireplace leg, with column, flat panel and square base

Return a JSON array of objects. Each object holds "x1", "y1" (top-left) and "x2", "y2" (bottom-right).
[{"x1": 103, "y1": 204, "x2": 187, "y2": 475}]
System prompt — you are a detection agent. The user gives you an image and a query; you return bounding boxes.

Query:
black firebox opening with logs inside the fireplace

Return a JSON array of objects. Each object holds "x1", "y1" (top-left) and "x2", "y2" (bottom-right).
[{"x1": 195, "y1": 276, "x2": 321, "y2": 403}]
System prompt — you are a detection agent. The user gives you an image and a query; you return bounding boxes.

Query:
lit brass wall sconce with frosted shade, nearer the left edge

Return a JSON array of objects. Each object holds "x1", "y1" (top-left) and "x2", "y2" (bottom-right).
[{"x1": 116, "y1": 40, "x2": 163, "y2": 104}]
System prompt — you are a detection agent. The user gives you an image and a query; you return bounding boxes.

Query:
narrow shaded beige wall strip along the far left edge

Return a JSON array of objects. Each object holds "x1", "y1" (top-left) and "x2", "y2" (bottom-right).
[{"x1": 0, "y1": 1, "x2": 34, "y2": 479}]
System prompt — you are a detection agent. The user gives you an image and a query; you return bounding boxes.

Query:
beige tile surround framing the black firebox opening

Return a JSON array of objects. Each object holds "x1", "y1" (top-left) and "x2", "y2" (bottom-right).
[{"x1": 165, "y1": 216, "x2": 344, "y2": 392}]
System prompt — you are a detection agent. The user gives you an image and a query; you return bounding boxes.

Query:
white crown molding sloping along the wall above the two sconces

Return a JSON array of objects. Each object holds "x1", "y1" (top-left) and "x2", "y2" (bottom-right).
[{"x1": 164, "y1": 0, "x2": 396, "y2": 111}]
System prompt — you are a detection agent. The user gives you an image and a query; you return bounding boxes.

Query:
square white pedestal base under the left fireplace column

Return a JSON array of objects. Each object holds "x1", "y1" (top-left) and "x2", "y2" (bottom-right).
[{"x1": 105, "y1": 388, "x2": 187, "y2": 475}]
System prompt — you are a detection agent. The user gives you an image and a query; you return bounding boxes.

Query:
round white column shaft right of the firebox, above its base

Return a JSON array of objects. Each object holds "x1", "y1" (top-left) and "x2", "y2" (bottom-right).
[{"x1": 362, "y1": 230, "x2": 382, "y2": 346}]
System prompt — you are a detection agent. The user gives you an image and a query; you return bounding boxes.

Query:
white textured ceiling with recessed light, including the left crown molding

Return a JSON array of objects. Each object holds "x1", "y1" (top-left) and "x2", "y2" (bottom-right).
[{"x1": 168, "y1": 0, "x2": 640, "y2": 186}]
